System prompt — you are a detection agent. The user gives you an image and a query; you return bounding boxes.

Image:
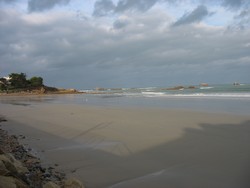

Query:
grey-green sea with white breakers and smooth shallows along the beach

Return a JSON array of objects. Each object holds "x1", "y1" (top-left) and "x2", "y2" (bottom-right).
[{"x1": 0, "y1": 84, "x2": 250, "y2": 115}]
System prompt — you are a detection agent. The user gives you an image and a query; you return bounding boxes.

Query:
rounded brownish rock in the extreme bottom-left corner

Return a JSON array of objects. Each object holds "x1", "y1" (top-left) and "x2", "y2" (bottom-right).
[{"x1": 0, "y1": 176, "x2": 28, "y2": 188}]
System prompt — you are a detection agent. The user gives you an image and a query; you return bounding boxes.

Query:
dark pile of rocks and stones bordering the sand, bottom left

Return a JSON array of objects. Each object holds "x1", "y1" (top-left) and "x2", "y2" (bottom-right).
[{"x1": 0, "y1": 117, "x2": 84, "y2": 188}]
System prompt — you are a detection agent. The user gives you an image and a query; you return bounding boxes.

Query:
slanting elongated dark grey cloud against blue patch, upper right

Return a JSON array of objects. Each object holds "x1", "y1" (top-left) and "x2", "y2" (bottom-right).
[{"x1": 173, "y1": 5, "x2": 209, "y2": 26}]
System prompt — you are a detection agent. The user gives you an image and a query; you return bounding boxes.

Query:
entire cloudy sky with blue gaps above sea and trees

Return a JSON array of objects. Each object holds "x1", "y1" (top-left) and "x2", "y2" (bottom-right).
[{"x1": 0, "y1": 0, "x2": 250, "y2": 89}]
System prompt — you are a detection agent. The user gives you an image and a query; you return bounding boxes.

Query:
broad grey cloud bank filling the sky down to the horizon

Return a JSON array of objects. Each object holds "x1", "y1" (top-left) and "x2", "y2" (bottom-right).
[{"x1": 0, "y1": 7, "x2": 250, "y2": 88}]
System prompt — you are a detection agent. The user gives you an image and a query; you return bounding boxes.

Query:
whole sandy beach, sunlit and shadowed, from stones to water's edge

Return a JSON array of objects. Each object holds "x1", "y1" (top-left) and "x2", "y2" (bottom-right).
[{"x1": 0, "y1": 104, "x2": 250, "y2": 188}]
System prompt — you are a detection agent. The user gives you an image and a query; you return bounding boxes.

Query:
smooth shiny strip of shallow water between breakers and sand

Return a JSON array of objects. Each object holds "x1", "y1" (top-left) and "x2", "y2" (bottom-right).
[{"x1": 0, "y1": 93, "x2": 250, "y2": 116}]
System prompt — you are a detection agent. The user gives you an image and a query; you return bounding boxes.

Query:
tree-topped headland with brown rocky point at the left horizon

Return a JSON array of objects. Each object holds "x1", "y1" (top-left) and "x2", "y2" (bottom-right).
[{"x1": 0, "y1": 73, "x2": 80, "y2": 95}]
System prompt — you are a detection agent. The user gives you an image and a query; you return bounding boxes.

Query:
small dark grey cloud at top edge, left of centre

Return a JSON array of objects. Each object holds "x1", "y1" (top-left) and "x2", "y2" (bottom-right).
[{"x1": 28, "y1": 0, "x2": 71, "y2": 12}]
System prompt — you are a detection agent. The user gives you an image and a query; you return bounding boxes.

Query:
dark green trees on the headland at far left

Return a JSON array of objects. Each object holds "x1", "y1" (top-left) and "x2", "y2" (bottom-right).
[{"x1": 0, "y1": 73, "x2": 44, "y2": 92}]
